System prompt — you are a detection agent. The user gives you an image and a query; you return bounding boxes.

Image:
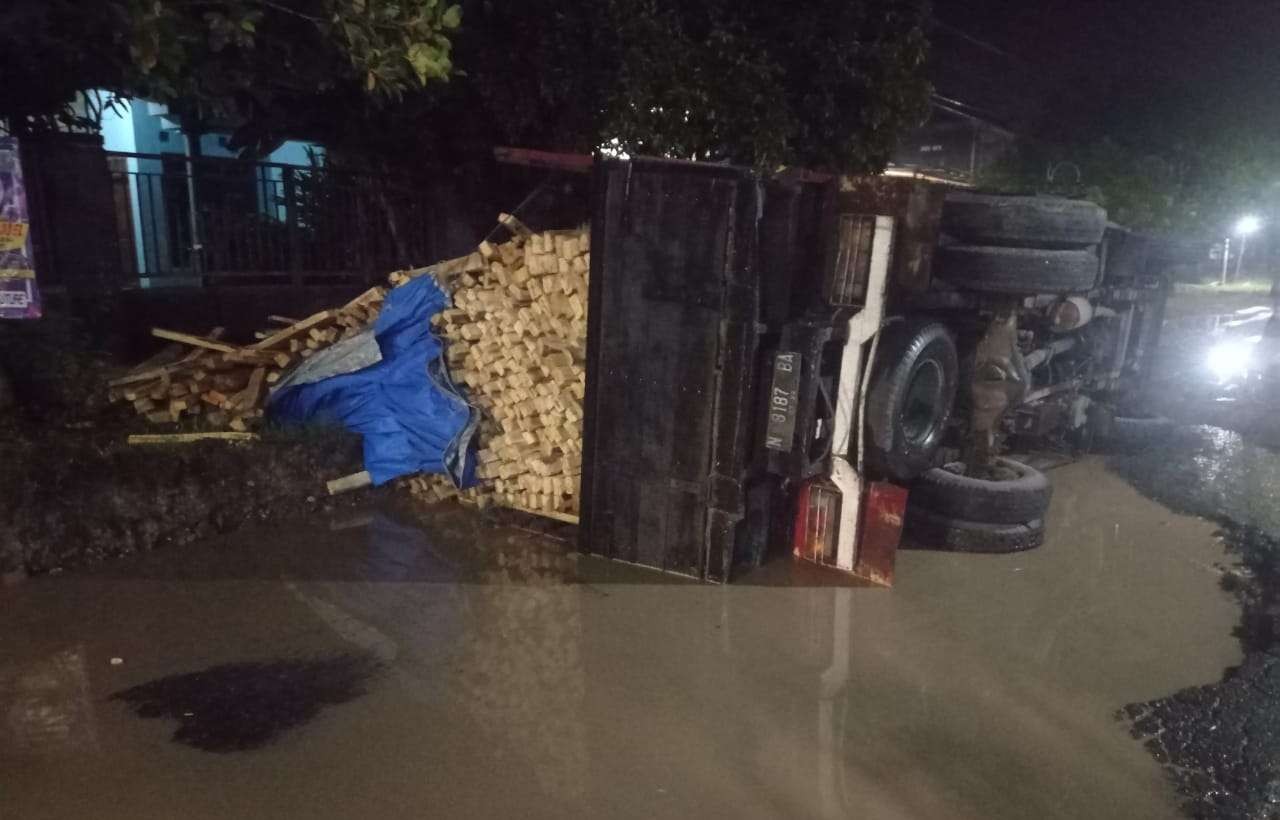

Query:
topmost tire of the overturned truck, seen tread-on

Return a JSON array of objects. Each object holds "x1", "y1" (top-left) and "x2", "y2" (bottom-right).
[{"x1": 942, "y1": 192, "x2": 1107, "y2": 248}]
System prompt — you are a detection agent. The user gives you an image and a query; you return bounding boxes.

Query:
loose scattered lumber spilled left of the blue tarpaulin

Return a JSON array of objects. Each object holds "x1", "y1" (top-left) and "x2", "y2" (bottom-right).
[{"x1": 108, "y1": 287, "x2": 387, "y2": 431}]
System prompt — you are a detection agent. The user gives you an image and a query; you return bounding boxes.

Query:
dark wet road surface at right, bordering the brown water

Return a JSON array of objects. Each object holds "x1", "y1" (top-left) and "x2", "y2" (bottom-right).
[{"x1": 1111, "y1": 426, "x2": 1280, "y2": 819}]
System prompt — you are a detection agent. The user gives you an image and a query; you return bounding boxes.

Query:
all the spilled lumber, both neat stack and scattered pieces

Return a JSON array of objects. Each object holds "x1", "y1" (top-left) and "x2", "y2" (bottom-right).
[{"x1": 109, "y1": 207, "x2": 591, "y2": 521}]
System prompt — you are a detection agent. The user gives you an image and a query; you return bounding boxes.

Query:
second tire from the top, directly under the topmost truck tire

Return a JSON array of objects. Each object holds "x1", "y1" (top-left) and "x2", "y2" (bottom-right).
[{"x1": 937, "y1": 244, "x2": 1098, "y2": 296}]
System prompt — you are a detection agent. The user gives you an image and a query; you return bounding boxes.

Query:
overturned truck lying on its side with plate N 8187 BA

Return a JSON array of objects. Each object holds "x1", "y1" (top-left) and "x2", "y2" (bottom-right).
[{"x1": 560, "y1": 156, "x2": 1167, "y2": 582}]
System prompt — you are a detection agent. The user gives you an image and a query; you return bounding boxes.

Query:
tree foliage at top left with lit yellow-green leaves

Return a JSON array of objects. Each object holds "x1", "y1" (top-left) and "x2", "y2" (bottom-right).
[{"x1": 0, "y1": 0, "x2": 461, "y2": 134}]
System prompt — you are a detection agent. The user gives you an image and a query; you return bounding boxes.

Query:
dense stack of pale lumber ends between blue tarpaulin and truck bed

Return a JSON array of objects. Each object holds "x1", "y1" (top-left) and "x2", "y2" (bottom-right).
[{"x1": 404, "y1": 214, "x2": 590, "y2": 521}]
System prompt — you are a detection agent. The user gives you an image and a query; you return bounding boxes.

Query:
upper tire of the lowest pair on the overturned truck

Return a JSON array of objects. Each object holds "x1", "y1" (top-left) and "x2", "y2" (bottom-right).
[{"x1": 909, "y1": 458, "x2": 1053, "y2": 524}]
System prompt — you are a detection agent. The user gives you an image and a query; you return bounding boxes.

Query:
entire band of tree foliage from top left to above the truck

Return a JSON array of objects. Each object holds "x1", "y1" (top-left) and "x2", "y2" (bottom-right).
[{"x1": 0, "y1": 0, "x2": 929, "y2": 171}]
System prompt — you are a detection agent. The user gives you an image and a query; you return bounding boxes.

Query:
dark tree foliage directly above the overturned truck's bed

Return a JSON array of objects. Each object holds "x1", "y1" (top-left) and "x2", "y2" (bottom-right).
[{"x1": 458, "y1": 0, "x2": 929, "y2": 171}]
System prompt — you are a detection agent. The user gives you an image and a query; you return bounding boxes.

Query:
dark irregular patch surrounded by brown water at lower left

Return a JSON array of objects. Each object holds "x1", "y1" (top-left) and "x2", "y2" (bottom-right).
[{"x1": 111, "y1": 655, "x2": 379, "y2": 752}]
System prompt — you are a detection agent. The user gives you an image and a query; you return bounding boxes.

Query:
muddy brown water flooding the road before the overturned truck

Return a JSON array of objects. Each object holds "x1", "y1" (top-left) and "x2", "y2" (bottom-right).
[{"x1": 0, "y1": 473, "x2": 1240, "y2": 820}]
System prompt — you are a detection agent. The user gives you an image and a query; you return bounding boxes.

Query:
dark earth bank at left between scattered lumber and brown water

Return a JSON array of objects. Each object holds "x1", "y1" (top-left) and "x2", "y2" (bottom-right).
[{"x1": 0, "y1": 307, "x2": 378, "y2": 574}]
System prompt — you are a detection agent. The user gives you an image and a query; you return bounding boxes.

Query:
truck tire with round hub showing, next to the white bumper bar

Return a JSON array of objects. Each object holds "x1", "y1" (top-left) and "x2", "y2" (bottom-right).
[{"x1": 867, "y1": 322, "x2": 960, "y2": 482}]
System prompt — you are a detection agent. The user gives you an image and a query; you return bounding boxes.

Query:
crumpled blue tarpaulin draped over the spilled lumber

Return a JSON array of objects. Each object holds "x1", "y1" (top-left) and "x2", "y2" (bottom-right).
[{"x1": 270, "y1": 276, "x2": 477, "y2": 487}]
